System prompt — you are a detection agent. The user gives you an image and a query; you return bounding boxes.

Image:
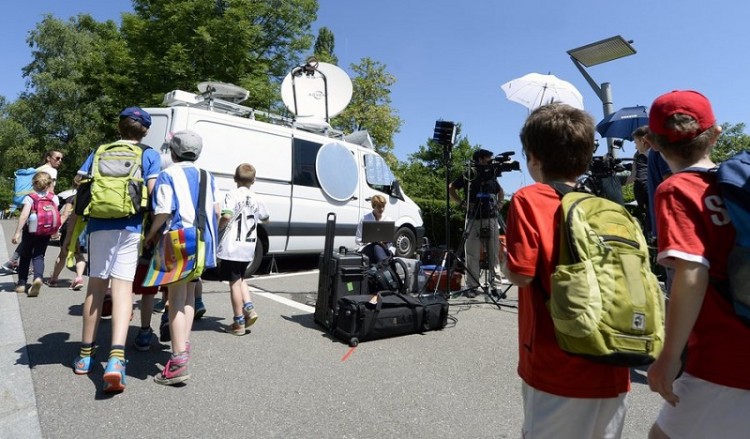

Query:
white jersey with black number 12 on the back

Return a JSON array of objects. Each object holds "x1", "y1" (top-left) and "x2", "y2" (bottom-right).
[{"x1": 216, "y1": 186, "x2": 268, "y2": 262}]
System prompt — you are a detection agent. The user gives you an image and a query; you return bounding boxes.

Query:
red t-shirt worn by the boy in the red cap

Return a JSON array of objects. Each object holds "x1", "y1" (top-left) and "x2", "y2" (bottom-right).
[{"x1": 655, "y1": 172, "x2": 750, "y2": 390}]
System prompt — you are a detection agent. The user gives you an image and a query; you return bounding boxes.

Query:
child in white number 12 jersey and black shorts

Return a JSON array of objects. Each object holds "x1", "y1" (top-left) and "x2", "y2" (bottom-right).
[{"x1": 216, "y1": 163, "x2": 268, "y2": 335}]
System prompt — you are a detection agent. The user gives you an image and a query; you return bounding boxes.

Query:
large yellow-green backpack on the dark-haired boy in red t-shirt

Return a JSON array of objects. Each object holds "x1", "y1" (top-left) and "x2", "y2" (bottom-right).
[{"x1": 549, "y1": 186, "x2": 664, "y2": 367}]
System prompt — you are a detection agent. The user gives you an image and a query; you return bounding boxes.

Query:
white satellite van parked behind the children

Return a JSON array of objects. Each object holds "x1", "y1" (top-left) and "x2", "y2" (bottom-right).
[{"x1": 143, "y1": 63, "x2": 424, "y2": 273}]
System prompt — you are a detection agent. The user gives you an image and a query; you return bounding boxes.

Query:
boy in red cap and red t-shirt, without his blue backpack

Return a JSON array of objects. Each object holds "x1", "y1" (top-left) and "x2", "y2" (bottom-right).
[{"x1": 648, "y1": 91, "x2": 750, "y2": 438}]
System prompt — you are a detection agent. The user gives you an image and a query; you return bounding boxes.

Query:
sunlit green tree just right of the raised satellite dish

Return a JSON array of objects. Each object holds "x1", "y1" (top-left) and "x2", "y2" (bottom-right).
[{"x1": 331, "y1": 58, "x2": 403, "y2": 156}]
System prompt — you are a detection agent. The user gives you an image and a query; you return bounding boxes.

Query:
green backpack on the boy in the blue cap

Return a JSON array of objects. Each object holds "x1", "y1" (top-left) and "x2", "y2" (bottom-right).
[{"x1": 75, "y1": 141, "x2": 148, "y2": 219}]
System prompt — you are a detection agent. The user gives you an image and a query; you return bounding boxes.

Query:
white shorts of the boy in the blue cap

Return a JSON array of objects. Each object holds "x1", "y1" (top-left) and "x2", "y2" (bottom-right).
[{"x1": 89, "y1": 230, "x2": 141, "y2": 281}]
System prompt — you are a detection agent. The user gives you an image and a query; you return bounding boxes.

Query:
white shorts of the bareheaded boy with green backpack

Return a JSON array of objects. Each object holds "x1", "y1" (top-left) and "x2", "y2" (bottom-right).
[{"x1": 521, "y1": 382, "x2": 628, "y2": 439}]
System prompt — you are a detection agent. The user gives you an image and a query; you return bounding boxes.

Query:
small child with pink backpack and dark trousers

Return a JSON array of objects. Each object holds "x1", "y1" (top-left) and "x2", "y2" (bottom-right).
[{"x1": 11, "y1": 171, "x2": 60, "y2": 297}]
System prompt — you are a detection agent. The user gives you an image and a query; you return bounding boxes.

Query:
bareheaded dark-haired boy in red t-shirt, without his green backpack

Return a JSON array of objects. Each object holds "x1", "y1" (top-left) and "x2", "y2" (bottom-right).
[{"x1": 504, "y1": 104, "x2": 630, "y2": 438}]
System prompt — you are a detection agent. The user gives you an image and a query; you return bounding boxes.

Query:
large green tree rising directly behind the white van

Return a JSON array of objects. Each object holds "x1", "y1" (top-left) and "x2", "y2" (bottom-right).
[{"x1": 122, "y1": 0, "x2": 318, "y2": 108}]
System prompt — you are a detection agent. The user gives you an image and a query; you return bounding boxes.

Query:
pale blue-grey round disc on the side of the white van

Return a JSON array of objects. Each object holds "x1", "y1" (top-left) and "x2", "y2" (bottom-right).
[{"x1": 315, "y1": 142, "x2": 359, "y2": 201}]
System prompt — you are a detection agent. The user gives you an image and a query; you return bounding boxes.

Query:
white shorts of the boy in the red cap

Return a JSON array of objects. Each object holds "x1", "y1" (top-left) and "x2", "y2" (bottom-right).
[{"x1": 656, "y1": 373, "x2": 750, "y2": 439}]
